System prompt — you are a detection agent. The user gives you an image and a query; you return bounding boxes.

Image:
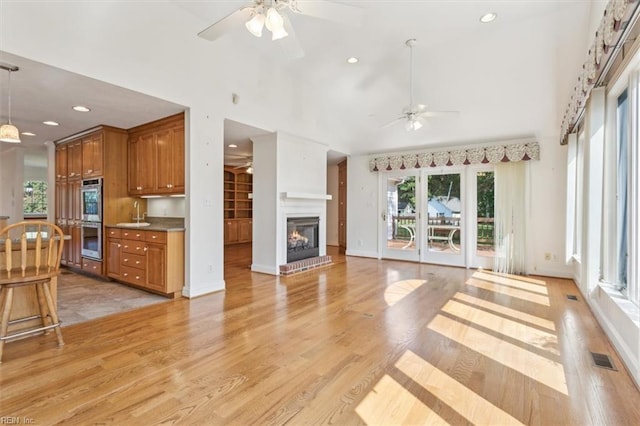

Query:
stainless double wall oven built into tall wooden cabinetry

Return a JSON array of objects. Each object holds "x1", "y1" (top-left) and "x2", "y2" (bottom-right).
[{"x1": 80, "y1": 178, "x2": 102, "y2": 260}]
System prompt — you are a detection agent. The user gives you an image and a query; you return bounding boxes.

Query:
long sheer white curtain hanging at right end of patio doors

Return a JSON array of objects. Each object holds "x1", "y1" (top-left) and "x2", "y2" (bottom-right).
[{"x1": 493, "y1": 161, "x2": 526, "y2": 275}]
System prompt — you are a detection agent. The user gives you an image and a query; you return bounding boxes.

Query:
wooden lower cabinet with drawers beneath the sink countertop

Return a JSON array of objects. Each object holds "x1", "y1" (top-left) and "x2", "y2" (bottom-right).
[{"x1": 106, "y1": 227, "x2": 184, "y2": 297}]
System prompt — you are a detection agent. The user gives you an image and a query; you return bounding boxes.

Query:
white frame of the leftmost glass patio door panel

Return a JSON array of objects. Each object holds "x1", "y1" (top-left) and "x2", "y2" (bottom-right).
[{"x1": 378, "y1": 170, "x2": 422, "y2": 262}]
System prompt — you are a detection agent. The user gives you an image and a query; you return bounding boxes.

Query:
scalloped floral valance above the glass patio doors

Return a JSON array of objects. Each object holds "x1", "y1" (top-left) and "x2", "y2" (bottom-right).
[{"x1": 369, "y1": 142, "x2": 540, "y2": 172}]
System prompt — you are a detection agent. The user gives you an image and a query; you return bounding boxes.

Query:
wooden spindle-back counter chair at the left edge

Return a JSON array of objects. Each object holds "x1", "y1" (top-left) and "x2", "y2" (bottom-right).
[{"x1": 0, "y1": 221, "x2": 64, "y2": 363}]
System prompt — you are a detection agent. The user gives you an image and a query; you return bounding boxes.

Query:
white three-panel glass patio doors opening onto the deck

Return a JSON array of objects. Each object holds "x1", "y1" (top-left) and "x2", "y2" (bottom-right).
[{"x1": 379, "y1": 165, "x2": 494, "y2": 268}]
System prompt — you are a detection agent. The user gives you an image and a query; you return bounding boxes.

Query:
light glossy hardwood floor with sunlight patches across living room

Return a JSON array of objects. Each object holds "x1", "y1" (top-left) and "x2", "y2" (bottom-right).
[{"x1": 0, "y1": 246, "x2": 640, "y2": 425}]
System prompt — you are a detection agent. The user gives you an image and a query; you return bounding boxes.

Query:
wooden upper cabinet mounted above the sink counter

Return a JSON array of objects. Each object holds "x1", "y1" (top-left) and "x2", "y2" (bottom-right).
[{"x1": 128, "y1": 113, "x2": 185, "y2": 195}]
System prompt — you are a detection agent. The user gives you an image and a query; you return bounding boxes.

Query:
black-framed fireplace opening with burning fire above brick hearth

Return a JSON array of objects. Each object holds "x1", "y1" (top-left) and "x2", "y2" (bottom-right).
[{"x1": 287, "y1": 217, "x2": 320, "y2": 263}]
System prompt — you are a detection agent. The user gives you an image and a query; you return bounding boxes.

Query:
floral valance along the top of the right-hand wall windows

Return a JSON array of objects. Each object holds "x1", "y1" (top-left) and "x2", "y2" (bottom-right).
[{"x1": 560, "y1": 0, "x2": 640, "y2": 145}]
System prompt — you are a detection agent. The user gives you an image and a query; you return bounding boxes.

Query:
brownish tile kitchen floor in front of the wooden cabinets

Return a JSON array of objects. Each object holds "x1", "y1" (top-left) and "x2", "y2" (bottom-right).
[{"x1": 58, "y1": 269, "x2": 170, "y2": 326}]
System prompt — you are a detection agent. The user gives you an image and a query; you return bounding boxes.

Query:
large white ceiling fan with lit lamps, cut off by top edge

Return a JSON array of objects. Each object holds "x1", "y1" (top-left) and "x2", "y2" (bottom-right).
[{"x1": 198, "y1": 0, "x2": 363, "y2": 56}]
